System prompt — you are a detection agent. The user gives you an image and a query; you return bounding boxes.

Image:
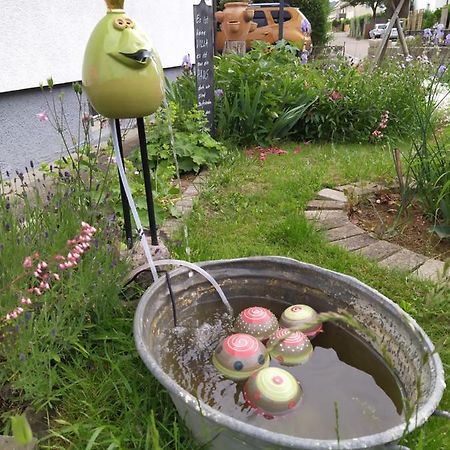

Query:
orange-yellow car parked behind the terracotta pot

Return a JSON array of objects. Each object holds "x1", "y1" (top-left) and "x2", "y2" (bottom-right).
[{"x1": 216, "y1": 3, "x2": 312, "y2": 52}]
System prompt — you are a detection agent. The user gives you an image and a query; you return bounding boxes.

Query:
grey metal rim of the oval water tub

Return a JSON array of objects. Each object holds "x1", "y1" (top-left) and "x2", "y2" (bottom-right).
[{"x1": 133, "y1": 256, "x2": 445, "y2": 450}]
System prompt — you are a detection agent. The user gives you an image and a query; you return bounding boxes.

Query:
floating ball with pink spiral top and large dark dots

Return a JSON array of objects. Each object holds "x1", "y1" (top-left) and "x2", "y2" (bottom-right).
[{"x1": 212, "y1": 333, "x2": 270, "y2": 381}]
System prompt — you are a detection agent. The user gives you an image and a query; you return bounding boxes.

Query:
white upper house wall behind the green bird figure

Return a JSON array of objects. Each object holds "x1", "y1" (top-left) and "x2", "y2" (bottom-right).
[{"x1": 0, "y1": 0, "x2": 194, "y2": 92}]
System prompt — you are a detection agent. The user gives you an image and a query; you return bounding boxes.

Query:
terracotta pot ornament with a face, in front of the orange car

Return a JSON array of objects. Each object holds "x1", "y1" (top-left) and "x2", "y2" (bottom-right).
[{"x1": 216, "y1": 2, "x2": 257, "y2": 41}]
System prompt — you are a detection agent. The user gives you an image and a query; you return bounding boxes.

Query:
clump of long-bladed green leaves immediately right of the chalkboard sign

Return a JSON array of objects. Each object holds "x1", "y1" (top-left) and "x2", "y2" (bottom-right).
[{"x1": 216, "y1": 42, "x2": 317, "y2": 145}]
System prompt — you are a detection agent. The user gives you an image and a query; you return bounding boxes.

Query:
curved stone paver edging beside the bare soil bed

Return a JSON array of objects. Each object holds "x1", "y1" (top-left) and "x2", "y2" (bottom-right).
[{"x1": 305, "y1": 184, "x2": 448, "y2": 281}]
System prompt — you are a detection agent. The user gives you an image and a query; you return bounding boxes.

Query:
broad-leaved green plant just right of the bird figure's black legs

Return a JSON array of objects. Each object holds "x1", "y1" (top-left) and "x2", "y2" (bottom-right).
[{"x1": 147, "y1": 102, "x2": 224, "y2": 172}]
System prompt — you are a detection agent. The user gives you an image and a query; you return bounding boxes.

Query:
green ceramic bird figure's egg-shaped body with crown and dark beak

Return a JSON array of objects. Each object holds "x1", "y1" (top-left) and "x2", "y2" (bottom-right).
[{"x1": 83, "y1": 0, "x2": 164, "y2": 119}]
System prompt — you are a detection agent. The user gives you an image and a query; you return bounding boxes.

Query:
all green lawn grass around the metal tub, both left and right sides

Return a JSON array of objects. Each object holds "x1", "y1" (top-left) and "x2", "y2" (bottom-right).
[{"x1": 1, "y1": 143, "x2": 450, "y2": 450}]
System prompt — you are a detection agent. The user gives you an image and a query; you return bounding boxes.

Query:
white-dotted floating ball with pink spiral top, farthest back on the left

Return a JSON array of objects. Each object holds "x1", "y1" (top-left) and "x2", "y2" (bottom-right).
[{"x1": 234, "y1": 306, "x2": 278, "y2": 341}]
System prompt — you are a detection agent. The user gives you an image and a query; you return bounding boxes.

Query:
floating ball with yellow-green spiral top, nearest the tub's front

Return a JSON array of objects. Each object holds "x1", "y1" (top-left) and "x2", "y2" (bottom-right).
[{"x1": 244, "y1": 367, "x2": 302, "y2": 417}]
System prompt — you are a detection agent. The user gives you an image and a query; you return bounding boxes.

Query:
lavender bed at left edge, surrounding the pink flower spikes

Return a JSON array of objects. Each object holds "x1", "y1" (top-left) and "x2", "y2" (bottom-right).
[{"x1": 0, "y1": 176, "x2": 124, "y2": 412}]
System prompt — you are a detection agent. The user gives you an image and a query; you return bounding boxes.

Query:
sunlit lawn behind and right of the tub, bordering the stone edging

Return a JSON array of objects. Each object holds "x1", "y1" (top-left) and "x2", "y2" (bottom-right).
[{"x1": 173, "y1": 143, "x2": 450, "y2": 449}]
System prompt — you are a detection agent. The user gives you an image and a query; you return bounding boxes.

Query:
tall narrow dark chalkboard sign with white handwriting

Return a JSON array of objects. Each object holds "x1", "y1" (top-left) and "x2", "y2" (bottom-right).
[{"x1": 194, "y1": 0, "x2": 214, "y2": 134}]
